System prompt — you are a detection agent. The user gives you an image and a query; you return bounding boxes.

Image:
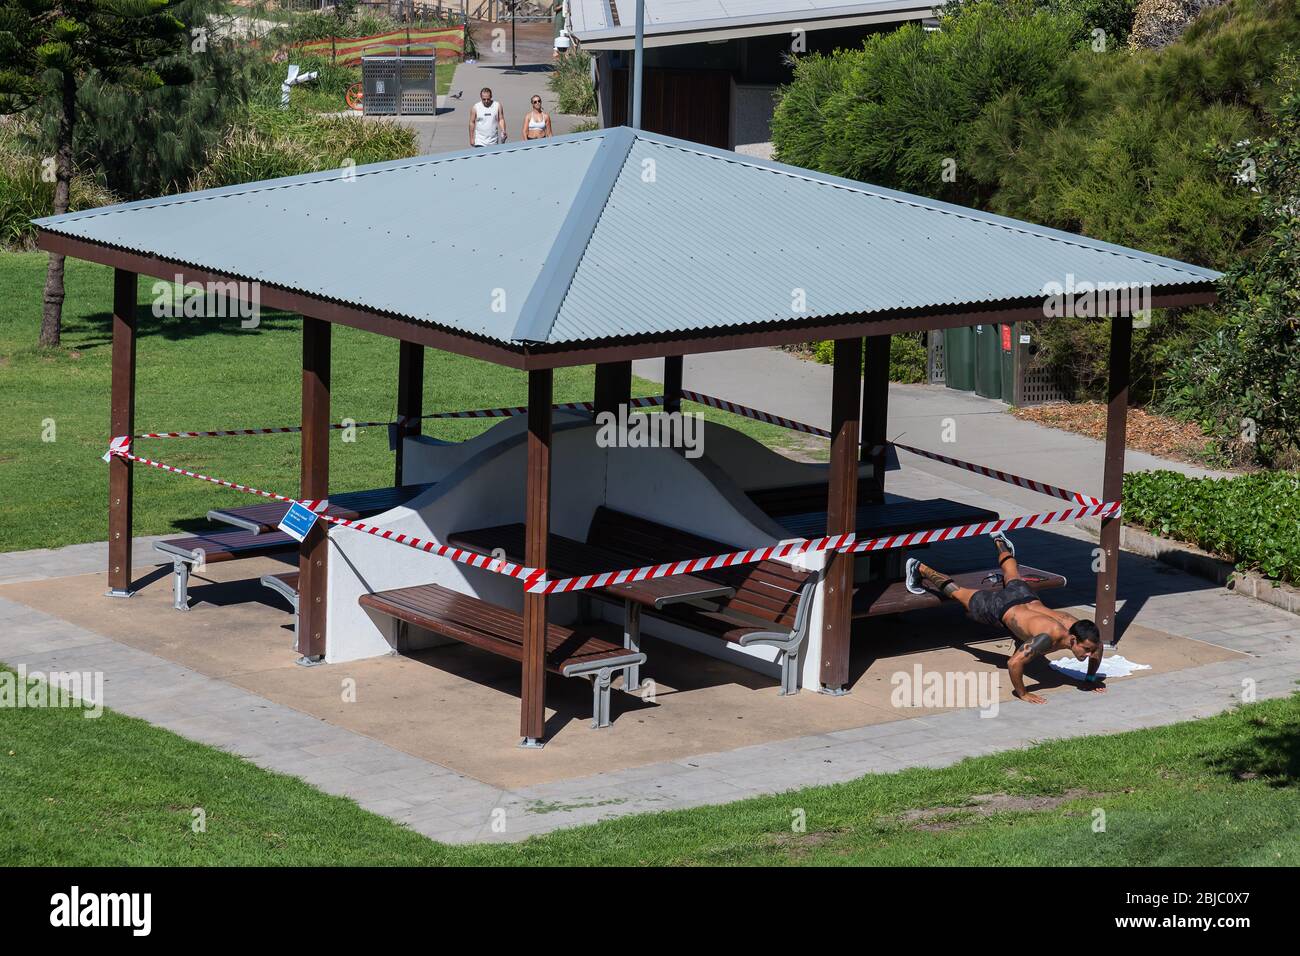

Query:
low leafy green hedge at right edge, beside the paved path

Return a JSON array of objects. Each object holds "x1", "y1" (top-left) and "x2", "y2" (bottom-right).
[{"x1": 1125, "y1": 471, "x2": 1300, "y2": 584}]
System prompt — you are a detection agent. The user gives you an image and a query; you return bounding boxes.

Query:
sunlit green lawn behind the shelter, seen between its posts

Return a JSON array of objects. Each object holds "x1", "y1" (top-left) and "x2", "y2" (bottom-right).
[{"x1": 0, "y1": 252, "x2": 800, "y2": 551}]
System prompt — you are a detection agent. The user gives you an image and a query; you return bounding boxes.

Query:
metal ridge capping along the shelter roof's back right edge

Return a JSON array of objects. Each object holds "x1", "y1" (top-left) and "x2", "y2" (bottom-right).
[{"x1": 647, "y1": 135, "x2": 1214, "y2": 278}]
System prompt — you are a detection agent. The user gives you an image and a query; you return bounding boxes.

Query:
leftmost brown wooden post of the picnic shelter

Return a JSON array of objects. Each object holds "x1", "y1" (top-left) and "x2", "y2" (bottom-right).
[{"x1": 108, "y1": 269, "x2": 138, "y2": 597}]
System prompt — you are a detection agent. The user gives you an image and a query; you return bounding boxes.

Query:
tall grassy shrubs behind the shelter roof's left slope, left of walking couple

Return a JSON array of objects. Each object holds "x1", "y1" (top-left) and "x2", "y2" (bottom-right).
[{"x1": 191, "y1": 107, "x2": 417, "y2": 189}]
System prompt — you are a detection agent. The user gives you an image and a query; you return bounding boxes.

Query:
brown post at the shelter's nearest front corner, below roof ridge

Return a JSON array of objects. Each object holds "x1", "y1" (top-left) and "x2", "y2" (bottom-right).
[{"x1": 519, "y1": 368, "x2": 553, "y2": 747}]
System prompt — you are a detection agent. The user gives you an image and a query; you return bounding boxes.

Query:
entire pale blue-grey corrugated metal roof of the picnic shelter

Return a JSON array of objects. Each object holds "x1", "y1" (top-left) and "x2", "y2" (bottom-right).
[{"x1": 38, "y1": 127, "x2": 1219, "y2": 345}]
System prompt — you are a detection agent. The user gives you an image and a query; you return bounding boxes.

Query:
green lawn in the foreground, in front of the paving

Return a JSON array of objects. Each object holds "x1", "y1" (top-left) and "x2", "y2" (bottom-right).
[{"x1": 0, "y1": 671, "x2": 1300, "y2": 866}]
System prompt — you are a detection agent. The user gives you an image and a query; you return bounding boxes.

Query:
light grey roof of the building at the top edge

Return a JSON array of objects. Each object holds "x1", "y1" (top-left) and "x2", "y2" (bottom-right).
[{"x1": 566, "y1": 0, "x2": 945, "y2": 49}]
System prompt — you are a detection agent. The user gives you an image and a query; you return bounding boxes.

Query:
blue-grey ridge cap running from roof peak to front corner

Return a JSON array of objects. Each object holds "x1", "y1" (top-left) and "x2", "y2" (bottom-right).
[{"x1": 511, "y1": 126, "x2": 637, "y2": 343}]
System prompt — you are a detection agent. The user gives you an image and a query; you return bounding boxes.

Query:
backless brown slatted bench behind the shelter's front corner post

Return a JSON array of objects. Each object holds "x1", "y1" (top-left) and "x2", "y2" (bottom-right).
[{"x1": 359, "y1": 584, "x2": 646, "y2": 727}]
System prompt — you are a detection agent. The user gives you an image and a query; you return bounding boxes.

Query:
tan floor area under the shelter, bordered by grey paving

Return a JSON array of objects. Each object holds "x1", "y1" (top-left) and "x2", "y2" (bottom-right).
[{"x1": 0, "y1": 559, "x2": 1238, "y2": 787}]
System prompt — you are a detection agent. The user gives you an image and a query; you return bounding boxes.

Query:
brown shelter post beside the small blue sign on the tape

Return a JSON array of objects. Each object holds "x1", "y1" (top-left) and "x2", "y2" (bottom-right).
[{"x1": 298, "y1": 316, "x2": 330, "y2": 663}]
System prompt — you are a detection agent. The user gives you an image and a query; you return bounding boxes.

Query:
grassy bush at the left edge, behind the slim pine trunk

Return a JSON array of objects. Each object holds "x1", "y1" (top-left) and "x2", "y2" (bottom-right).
[{"x1": 0, "y1": 120, "x2": 117, "y2": 250}]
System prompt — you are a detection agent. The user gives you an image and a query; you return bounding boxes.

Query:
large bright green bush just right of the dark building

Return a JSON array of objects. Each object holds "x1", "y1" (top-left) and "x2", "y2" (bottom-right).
[{"x1": 772, "y1": 0, "x2": 1082, "y2": 204}]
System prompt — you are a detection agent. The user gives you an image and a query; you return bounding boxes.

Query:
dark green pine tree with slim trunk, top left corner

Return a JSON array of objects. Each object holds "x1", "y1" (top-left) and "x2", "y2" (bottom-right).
[{"x1": 0, "y1": 0, "x2": 192, "y2": 347}]
